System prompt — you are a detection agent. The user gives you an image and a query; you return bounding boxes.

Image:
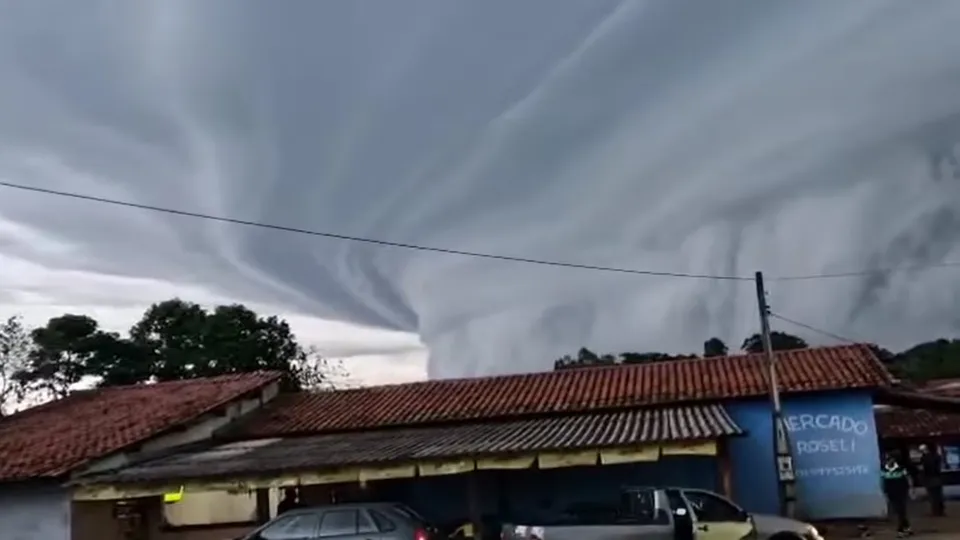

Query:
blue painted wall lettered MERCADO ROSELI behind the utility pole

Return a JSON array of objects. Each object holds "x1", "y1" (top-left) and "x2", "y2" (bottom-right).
[{"x1": 726, "y1": 392, "x2": 886, "y2": 519}]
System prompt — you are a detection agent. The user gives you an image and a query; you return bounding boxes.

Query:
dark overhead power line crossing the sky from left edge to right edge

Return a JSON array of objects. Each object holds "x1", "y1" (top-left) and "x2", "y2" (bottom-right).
[{"x1": 0, "y1": 181, "x2": 960, "y2": 282}]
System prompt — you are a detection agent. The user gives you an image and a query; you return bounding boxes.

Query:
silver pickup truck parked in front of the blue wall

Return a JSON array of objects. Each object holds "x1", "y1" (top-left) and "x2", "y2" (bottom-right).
[{"x1": 500, "y1": 488, "x2": 823, "y2": 540}]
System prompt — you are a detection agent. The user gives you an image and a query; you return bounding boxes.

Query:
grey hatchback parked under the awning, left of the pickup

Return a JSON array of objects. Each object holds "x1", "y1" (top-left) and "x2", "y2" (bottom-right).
[{"x1": 238, "y1": 503, "x2": 438, "y2": 540}]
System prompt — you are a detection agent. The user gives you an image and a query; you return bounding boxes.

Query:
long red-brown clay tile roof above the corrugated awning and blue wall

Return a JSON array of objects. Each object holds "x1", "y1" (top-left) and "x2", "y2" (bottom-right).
[{"x1": 236, "y1": 345, "x2": 892, "y2": 438}]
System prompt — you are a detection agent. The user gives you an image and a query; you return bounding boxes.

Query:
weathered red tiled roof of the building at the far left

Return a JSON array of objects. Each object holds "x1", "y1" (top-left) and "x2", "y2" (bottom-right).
[{"x1": 0, "y1": 373, "x2": 280, "y2": 482}]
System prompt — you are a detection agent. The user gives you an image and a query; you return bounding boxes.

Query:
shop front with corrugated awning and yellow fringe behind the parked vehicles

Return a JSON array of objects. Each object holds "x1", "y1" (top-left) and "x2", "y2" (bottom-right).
[{"x1": 74, "y1": 404, "x2": 743, "y2": 540}]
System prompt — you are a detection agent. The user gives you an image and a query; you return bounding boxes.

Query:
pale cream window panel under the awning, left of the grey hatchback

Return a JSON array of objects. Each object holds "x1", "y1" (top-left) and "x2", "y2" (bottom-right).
[{"x1": 163, "y1": 491, "x2": 257, "y2": 527}]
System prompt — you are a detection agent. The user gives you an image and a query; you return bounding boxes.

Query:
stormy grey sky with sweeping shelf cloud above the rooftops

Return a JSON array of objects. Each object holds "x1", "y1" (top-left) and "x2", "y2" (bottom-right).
[{"x1": 0, "y1": 0, "x2": 960, "y2": 384}]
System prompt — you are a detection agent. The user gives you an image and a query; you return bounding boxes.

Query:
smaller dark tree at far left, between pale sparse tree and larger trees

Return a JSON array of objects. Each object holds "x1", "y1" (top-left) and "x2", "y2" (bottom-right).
[{"x1": 14, "y1": 314, "x2": 100, "y2": 398}]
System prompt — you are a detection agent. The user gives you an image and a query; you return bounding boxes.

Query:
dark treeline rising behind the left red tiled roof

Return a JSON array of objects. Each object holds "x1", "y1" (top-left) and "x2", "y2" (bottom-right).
[{"x1": 0, "y1": 298, "x2": 342, "y2": 416}]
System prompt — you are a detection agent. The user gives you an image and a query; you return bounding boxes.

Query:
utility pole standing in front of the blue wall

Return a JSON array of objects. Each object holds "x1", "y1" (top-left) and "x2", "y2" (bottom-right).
[{"x1": 755, "y1": 272, "x2": 797, "y2": 518}]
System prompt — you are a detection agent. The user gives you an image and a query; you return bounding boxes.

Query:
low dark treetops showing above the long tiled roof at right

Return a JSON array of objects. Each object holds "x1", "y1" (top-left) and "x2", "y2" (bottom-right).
[{"x1": 553, "y1": 332, "x2": 960, "y2": 382}]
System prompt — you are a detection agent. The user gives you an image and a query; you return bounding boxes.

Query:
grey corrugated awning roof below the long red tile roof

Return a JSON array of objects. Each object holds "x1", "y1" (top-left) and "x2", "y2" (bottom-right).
[{"x1": 84, "y1": 404, "x2": 743, "y2": 483}]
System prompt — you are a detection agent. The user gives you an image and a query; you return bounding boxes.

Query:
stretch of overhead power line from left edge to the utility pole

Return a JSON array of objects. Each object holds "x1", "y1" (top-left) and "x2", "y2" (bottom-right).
[{"x1": 0, "y1": 181, "x2": 753, "y2": 281}]
